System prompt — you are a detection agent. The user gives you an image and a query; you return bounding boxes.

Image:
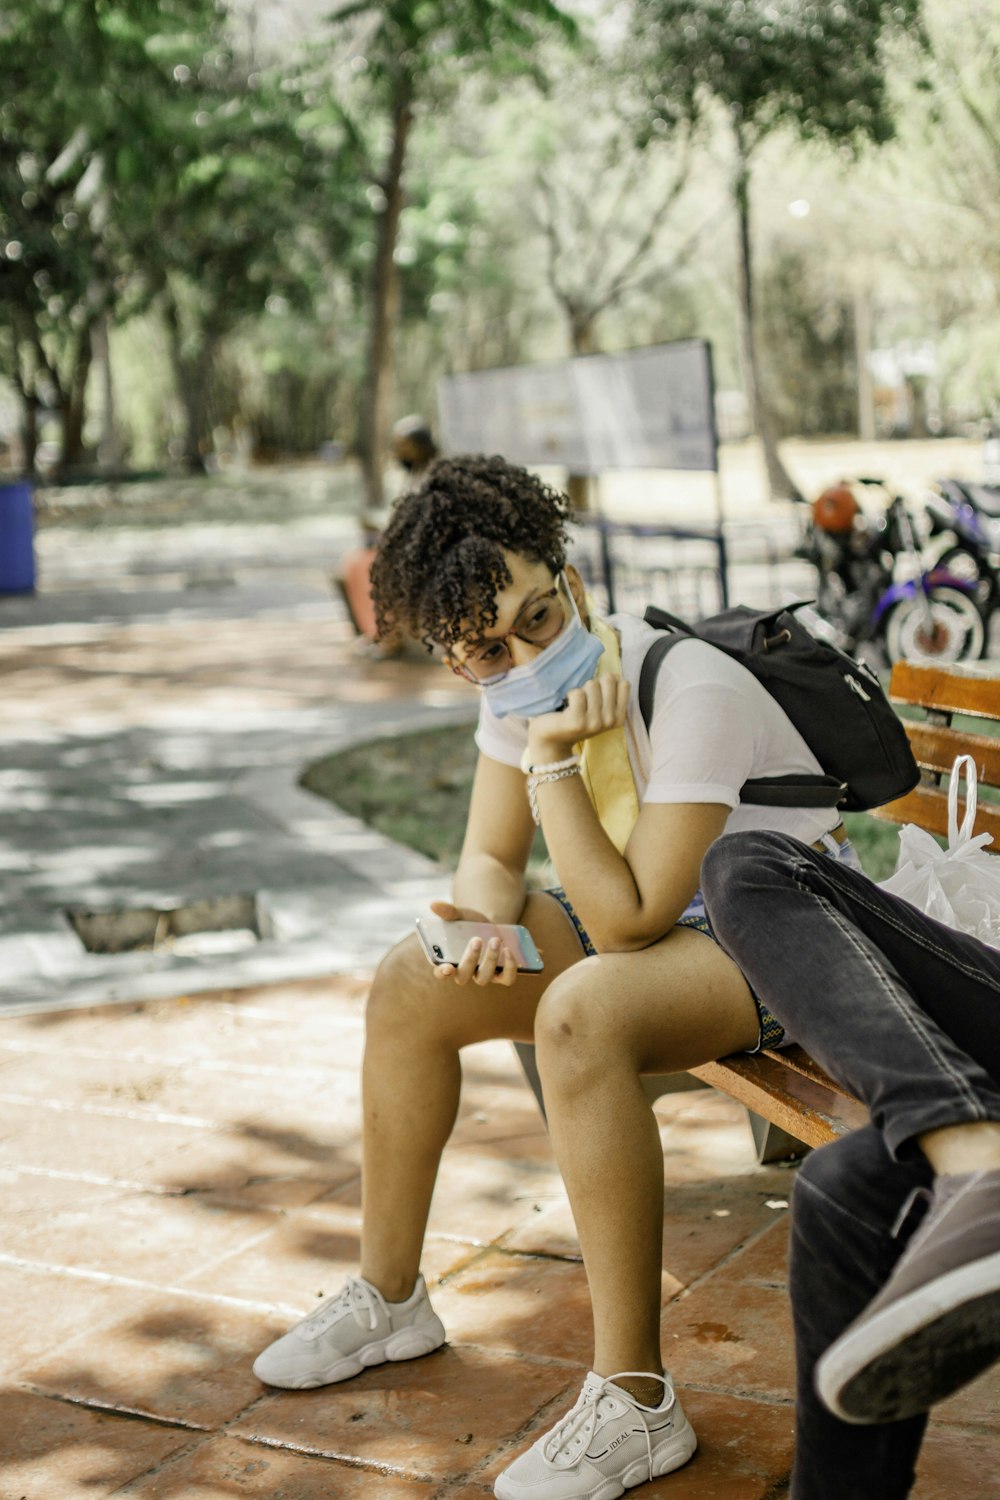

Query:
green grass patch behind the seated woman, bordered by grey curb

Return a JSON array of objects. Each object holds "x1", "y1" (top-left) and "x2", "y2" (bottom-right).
[{"x1": 301, "y1": 725, "x2": 900, "y2": 881}]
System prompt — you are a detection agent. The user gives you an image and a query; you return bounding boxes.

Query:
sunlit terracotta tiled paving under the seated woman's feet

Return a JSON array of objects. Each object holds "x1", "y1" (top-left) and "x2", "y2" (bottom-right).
[{"x1": 0, "y1": 980, "x2": 1000, "y2": 1500}]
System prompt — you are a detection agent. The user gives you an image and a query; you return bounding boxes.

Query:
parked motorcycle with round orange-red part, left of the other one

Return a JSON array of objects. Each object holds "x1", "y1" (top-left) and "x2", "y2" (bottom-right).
[{"x1": 798, "y1": 479, "x2": 987, "y2": 665}]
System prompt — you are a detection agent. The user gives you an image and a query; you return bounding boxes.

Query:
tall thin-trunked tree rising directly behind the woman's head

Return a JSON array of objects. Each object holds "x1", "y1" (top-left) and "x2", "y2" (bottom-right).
[{"x1": 325, "y1": 0, "x2": 577, "y2": 510}]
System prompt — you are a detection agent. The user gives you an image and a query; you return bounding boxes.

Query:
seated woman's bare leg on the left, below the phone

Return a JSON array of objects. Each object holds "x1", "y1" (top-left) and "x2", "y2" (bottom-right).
[{"x1": 361, "y1": 896, "x2": 580, "y2": 1302}]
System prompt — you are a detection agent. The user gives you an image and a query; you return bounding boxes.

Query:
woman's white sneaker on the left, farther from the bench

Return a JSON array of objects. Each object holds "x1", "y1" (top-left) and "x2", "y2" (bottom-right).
[{"x1": 253, "y1": 1277, "x2": 445, "y2": 1391}]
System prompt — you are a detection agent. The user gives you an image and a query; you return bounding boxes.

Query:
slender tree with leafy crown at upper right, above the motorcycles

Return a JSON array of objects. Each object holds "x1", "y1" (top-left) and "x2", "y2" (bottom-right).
[{"x1": 634, "y1": 0, "x2": 921, "y2": 495}]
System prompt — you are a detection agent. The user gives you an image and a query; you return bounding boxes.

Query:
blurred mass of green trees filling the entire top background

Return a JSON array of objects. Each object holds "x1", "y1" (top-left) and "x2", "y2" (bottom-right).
[{"x1": 9, "y1": 0, "x2": 1000, "y2": 494}]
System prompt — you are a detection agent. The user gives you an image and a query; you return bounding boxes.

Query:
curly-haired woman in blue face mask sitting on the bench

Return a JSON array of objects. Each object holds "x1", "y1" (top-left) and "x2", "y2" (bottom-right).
[{"x1": 255, "y1": 458, "x2": 853, "y2": 1500}]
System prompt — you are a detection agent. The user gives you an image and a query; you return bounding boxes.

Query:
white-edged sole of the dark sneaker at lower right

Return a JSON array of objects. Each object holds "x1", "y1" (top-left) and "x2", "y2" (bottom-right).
[{"x1": 816, "y1": 1254, "x2": 1000, "y2": 1425}]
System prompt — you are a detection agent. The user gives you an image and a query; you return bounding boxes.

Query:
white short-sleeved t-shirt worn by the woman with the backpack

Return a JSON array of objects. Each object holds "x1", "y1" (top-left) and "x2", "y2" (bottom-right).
[{"x1": 475, "y1": 615, "x2": 840, "y2": 843}]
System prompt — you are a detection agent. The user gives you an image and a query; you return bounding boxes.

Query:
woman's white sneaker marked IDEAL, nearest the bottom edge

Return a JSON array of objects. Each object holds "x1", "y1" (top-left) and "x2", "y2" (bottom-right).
[{"x1": 493, "y1": 1370, "x2": 697, "y2": 1500}]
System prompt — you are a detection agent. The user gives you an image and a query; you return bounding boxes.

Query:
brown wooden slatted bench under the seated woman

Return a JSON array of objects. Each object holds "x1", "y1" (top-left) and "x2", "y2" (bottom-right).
[{"x1": 517, "y1": 662, "x2": 1000, "y2": 1161}]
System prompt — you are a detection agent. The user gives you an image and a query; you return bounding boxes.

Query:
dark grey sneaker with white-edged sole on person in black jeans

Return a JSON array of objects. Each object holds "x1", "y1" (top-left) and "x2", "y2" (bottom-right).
[{"x1": 816, "y1": 1172, "x2": 1000, "y2": 1424}]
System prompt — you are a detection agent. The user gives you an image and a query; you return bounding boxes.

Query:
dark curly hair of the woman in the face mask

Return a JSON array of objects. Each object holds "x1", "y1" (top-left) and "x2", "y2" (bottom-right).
[{"x1": 372, "y1": 455, "x2": 571, "y2": 650}]
